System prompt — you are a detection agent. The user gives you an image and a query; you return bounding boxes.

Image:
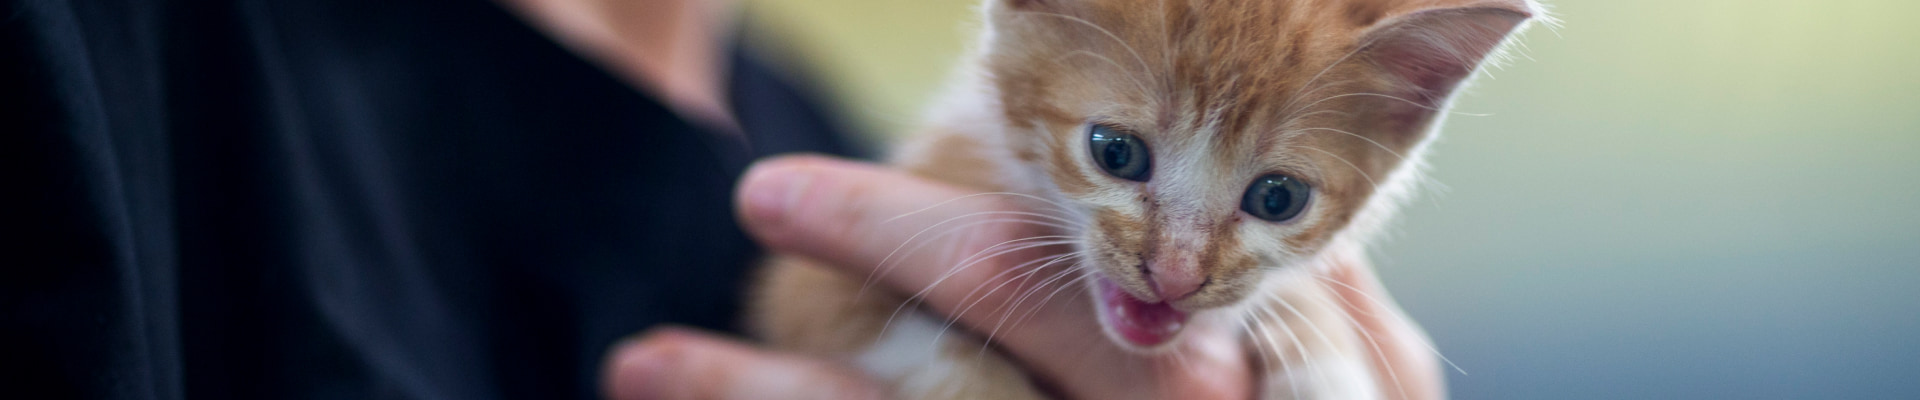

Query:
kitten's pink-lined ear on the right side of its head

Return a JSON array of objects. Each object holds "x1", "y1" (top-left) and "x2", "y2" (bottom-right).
[{"x1": 1361, "y1": 0, "x2": 1540, "y2": 110}]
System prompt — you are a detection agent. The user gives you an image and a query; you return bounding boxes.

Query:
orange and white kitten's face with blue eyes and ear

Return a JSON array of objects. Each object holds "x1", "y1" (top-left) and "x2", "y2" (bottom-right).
[{"x1": 987, "y1": 0, "x2": 1532, "y2": 348}]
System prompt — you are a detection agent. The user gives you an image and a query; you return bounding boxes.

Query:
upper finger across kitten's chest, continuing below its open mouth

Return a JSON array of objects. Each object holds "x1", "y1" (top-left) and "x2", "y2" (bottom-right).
[{"x1": 737, "y1": 156, "x2": 1246, "y2": 398}]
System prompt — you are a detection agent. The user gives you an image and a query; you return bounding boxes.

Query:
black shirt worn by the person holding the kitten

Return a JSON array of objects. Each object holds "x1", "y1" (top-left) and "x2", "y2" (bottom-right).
[{"x1": 0, "y1": 0, "x2": 847, "y2": 398}]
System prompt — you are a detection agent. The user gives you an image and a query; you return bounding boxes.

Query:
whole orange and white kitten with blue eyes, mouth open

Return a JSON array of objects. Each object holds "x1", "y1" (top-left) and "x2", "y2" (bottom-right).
[{"x1": 749, "y1": 0, "x2": 1544, "y2": 398}]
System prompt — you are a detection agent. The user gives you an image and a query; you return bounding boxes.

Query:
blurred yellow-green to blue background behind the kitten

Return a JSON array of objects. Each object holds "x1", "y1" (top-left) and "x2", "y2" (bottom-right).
[{"x1": 747, "y1": 0, "x2": 1920, "y2": 398}]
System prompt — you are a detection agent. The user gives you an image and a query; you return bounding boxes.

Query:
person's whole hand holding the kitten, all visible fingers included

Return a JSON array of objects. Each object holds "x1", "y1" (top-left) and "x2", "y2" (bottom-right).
[{"x1": 605, "y1": 156, "x2": 1440, "y2": 400}]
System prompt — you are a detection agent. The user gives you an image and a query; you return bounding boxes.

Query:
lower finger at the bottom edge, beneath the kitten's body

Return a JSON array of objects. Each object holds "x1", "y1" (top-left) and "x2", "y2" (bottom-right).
[{"x1": 603, "y1": 329, "x2": 881, "y2": 400}]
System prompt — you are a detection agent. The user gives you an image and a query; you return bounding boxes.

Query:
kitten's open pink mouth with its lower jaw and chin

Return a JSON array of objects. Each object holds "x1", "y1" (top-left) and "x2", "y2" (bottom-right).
[{"x1": 1094, "y1": 277, "x2": 1188, "y2": 352}]
